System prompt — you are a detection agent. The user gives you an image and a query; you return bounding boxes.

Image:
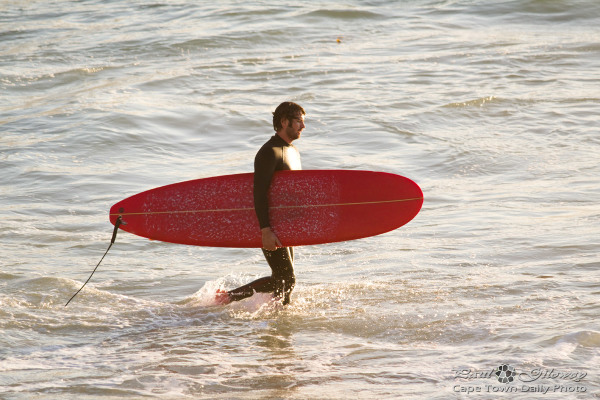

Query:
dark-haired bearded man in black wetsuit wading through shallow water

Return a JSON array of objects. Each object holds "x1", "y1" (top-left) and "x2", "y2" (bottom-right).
[{"x1": 216, "y1": 101, "x2": 306, "y2": 304}]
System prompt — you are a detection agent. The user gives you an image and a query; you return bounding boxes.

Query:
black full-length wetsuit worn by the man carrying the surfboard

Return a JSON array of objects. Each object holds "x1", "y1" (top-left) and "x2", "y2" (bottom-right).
[{"x1": 227, "y1": 135, "x2": 302, "y2": 304}]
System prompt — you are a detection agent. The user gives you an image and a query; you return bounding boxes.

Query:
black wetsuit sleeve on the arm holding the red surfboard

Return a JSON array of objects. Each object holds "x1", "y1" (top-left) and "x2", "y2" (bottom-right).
[{"x1": 254, "y1": 147, "x2": 277, "y2": 229}]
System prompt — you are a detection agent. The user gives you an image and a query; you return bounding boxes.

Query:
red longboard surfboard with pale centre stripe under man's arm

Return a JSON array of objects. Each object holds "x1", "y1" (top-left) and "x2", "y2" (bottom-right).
[{"x1": 110, "y1": 170, "x2": 423, "y2": 247}]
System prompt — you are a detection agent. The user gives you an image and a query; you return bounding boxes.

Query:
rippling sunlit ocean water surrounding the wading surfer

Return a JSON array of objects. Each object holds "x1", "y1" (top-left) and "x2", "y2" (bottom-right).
[{"x1": 0, "y1": 0, "x2": 600, "y2": 399}]
